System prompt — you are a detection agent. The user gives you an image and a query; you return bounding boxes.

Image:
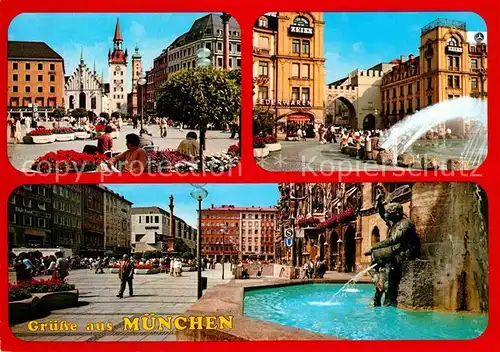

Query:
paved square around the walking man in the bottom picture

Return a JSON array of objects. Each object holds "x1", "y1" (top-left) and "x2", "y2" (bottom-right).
[{"x1": 11, "y1": 264, "x2": 232, "y2": 341}]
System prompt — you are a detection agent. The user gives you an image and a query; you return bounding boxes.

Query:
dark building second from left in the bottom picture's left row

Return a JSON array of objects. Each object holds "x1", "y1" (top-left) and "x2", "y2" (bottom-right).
[{"x1": 51, "y1": 184, "x2": 85, "y2": 252}]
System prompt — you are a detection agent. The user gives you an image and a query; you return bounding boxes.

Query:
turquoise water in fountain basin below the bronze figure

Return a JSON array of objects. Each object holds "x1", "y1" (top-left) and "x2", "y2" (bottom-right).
[{"x1": 244, "y1": 283, "x2": 488, "y2": 340}]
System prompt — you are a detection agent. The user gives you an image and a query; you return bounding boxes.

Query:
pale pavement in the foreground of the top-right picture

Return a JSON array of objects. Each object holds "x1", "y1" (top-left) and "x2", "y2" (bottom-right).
[{"x1": 257, "y1": 140, "x2": 405, "y2": 172}]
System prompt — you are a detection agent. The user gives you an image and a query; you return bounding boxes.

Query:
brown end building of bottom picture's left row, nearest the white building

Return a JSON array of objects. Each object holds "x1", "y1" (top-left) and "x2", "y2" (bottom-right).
[{"x1": 104, "y1": 188, "x2": 132, "y2": 256}]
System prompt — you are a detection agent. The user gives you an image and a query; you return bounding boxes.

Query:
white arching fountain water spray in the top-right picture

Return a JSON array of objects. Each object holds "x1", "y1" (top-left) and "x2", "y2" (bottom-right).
[{"x1": 382, "y1": 97, "x2": 487, "y2": 167}]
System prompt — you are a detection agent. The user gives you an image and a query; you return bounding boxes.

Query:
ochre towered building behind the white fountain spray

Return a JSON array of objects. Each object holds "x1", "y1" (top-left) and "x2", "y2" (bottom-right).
[{"x1": 381, "y1": 19, "x2": 488, "y2": 135}]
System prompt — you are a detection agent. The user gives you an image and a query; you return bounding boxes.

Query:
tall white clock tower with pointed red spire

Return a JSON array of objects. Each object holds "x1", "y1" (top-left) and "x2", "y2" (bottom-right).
[{"x1": 108, "y1": 19, "x2": 128, "y2": 114}]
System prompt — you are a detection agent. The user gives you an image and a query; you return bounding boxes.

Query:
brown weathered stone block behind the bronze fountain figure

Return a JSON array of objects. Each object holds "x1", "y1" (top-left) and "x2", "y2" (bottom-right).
[{"x1": 398, "y1": 183, "x2": 488, "y2": 312}]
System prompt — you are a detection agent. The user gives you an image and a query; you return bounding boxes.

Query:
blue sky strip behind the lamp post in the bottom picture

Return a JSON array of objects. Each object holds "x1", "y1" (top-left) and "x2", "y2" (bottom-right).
[{"x1": 105, "y1": 184, "x2": 279, "y2": 227}]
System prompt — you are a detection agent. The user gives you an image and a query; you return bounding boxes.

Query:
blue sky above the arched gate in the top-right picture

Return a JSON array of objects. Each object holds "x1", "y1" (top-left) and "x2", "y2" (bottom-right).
[{"x1": 323, "y1": 12, "x2": 486, "y2": 83}]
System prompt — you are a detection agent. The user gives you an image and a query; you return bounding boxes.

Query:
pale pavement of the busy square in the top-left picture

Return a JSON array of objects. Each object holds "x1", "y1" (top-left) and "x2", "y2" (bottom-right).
[{"x1": 7, "y1": 125, "x2": 238, "y2": 171}]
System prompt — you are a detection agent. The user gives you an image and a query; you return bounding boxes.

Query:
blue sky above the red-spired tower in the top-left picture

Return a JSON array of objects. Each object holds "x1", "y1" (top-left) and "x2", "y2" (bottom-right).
[{"x1": 8, "y1": 13, "x2": 211, "y2": 82}]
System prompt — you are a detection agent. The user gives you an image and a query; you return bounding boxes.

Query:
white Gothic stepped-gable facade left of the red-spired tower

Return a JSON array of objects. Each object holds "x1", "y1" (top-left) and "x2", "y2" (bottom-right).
[{"x1": 64, "y1": 49, "x2": 109, "y2": 116}]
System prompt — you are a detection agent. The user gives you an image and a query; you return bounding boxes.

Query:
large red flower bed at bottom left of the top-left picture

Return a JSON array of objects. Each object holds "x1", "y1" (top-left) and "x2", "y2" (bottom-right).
[{"x1": 31, "y1": 150, "x2": 108, "y2": 172}]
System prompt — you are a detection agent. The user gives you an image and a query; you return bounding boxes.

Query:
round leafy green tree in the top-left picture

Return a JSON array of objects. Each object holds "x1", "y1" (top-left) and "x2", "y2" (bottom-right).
[{"x1": 156, "y1": 67, "x2": 241, "y2": 146}]
